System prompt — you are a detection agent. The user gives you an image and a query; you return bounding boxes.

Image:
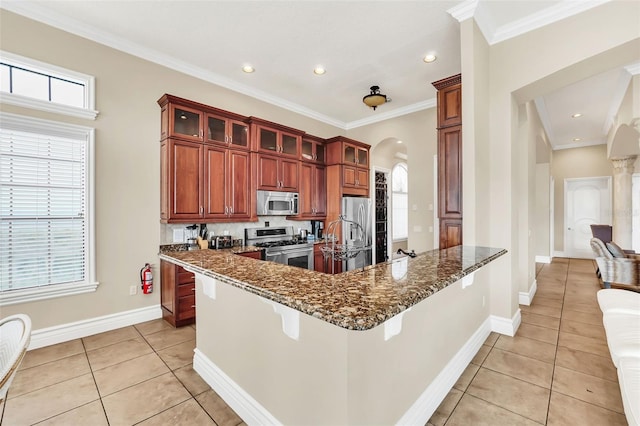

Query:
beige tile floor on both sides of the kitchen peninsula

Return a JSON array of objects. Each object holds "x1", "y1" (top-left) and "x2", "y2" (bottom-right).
[{"x1": 0, "y1": 259, "x2": 627, "y2": 426}]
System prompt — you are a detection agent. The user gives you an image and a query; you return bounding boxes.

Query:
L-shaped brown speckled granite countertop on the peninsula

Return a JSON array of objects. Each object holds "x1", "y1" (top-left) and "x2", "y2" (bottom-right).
[{"x1": 160, "y1": 246, "x2": 507, "y2": 330}]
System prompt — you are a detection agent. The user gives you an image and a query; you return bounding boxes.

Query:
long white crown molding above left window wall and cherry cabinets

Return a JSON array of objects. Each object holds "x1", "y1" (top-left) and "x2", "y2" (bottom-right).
[{"x1": 2, "y1": 1, "x2": 346, "y2": 129}]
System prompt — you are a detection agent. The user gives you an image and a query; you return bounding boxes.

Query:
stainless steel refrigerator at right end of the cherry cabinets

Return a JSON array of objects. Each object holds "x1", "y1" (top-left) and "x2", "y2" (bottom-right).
[{"x1": 342, "y1": 197, "x2": 373, "y2": 271}]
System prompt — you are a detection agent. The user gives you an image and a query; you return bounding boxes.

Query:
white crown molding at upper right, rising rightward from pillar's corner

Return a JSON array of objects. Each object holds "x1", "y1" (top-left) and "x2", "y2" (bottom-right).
[{"x1": 487, "y1": 0, "x2": 610, "y2": 45}]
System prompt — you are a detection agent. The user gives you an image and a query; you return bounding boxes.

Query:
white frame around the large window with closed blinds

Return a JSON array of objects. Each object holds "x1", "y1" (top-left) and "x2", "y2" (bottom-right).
[{"x1": 0, "y1": 111, "x2": 99, "y2": 306}]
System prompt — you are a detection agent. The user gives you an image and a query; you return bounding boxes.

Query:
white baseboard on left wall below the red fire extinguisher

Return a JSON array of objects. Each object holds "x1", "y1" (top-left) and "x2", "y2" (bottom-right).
[{"x1": 29, "y1": 305, "x2": 162, "y2": 350}]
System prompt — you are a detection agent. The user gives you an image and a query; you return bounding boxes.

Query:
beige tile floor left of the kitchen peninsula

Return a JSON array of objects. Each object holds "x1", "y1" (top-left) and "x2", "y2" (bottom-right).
[{"x1": 0, "y1": 320, "x2": 244, "y2": 426}]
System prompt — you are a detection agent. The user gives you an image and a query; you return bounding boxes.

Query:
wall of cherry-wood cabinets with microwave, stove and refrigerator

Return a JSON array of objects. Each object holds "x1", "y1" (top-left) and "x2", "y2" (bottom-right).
[{"x1": 158, "y1": 95, "x2": 378, "y2": 272}]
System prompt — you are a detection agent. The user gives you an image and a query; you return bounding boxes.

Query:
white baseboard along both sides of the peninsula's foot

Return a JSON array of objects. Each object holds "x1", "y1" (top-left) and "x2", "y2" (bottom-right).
[{"x1": 193, "y1": 318, "x2": 491, "y2": 425}]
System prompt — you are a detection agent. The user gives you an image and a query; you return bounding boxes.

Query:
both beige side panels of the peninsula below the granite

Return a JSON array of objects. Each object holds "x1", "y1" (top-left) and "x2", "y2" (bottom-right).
[{"x1": 196, "y1": 269, "x2": 489, "y2": 425}]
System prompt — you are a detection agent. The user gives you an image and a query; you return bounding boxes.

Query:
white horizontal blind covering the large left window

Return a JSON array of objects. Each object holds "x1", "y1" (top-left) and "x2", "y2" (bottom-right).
[{"x1": 0, "y1": 119, "x2": 90, "y2": 292}]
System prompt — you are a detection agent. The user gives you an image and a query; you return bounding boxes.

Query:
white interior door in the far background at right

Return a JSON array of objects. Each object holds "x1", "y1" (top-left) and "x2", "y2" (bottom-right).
[{"x1": 564, "y1": 176, "x2": 611, "y2": 259}]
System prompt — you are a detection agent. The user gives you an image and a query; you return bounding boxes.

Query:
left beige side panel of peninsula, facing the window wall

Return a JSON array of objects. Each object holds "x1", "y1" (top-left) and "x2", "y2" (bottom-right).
[{"x1": 196, "y1": 274, "x2": 348, "y2": 425}]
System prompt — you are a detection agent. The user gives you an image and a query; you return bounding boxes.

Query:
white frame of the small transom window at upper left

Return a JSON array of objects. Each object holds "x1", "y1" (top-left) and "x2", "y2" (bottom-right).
[{"x1": 0, "y1": 50, "x2": 98, "y2": 120}]
